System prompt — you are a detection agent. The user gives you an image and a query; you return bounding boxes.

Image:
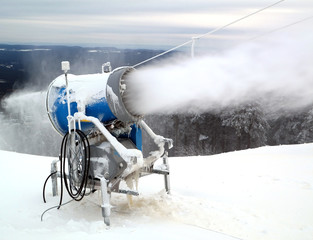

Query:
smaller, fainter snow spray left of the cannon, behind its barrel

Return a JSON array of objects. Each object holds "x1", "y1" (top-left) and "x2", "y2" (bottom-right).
[{"x1": 0, "y1": 90, "x2": 60, "y2": 156}]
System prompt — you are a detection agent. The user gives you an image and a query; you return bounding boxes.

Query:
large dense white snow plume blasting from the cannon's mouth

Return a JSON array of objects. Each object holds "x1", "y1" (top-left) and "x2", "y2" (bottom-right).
[{"x1": 127, "y1": 34, "x2": 313, "y2": 114}]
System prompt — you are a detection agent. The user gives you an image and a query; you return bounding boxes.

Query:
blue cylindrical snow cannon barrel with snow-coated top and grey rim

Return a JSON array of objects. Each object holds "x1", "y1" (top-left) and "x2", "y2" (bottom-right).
[{"x1": 46, "y1": 67, "x2": 142, "y2": 135}]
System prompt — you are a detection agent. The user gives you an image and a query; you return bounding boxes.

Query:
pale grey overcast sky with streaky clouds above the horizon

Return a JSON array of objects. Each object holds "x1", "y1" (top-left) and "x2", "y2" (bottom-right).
[{"x1": 0, "y1": 0, "x2": 313, "y2": 49}]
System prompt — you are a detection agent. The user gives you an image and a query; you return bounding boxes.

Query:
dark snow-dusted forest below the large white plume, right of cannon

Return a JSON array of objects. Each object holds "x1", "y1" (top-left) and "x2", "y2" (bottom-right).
[{"x1": 147, "y1": 103, "x2": 313, "y2": 156}]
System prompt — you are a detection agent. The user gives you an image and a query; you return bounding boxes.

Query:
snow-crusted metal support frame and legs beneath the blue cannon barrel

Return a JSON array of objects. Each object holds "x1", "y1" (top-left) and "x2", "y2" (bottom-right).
[{"x1": 51, "y1": 113, "x2": 173, "y2": 226}]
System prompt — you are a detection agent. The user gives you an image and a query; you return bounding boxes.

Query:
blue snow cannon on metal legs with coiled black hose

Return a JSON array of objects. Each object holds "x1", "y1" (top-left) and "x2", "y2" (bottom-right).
[{"x1": 43, "y1": 61, "x2": 173, "y2": 225}]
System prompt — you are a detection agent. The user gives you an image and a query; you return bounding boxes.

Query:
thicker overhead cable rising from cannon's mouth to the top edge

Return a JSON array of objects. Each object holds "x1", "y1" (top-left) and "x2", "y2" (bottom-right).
[{"x1": 132, "y1": 0, "x2": 285, "y2": 68}]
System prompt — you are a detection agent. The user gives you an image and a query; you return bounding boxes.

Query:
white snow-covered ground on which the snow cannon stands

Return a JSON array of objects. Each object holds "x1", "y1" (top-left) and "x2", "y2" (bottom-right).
[{"x1": 0, "y1": 144, "x2": 313, "y2": 240}]
